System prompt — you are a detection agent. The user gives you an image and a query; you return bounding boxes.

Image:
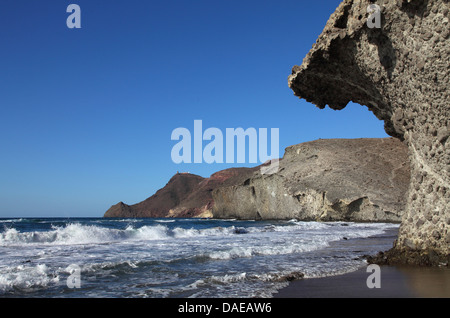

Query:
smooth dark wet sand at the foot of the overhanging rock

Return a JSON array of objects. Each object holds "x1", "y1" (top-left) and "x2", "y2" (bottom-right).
[{"x1": 274, "y1": 266, "x2": 450, "y2": 298}]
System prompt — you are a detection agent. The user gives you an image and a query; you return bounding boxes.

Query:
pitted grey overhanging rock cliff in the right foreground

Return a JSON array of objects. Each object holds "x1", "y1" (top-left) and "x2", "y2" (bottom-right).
[{"x1": 288, "y1": 0, "x2": 450, "y2": 264}]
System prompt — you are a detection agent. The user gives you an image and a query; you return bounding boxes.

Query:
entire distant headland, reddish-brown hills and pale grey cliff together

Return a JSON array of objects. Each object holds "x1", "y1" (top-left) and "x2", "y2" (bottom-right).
[{"x1": 105, "y1": 138, "x2": 409, "y2": 222}]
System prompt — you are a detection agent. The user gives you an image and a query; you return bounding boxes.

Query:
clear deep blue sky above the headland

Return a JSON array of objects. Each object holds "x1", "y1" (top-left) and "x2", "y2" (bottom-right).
[{"x1": 0, "y1": 0, "x2": 386, "y2": 217}]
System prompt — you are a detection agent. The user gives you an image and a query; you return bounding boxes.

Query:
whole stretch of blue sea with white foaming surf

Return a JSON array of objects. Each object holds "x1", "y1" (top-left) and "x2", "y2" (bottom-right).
[{"x1": 0, "y1": 218, "x2": 398, "y2": 298}]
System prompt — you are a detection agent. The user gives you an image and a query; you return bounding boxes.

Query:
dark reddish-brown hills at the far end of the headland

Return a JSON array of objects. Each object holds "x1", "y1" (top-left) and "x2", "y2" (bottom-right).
[{"x1": 104, "y1": 168, "x2": 258, "y2": 218}]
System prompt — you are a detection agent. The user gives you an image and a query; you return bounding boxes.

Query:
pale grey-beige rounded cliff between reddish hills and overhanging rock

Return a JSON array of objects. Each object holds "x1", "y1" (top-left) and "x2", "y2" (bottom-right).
[{"x1": 212, "y1": 138, "x2": 409, "y2": 222}]
